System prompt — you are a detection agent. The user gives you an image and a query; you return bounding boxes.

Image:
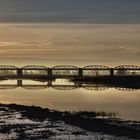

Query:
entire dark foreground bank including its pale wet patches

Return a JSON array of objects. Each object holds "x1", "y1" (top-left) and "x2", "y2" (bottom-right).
[{"x1": 0, "y1": 104, "x2": 140, "y2": 140}]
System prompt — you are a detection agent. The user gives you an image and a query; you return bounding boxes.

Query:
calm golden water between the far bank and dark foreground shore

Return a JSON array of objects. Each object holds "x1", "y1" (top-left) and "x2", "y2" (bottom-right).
[{"x1": 0, "y1": 79, "x2": 140, "y2": 121}]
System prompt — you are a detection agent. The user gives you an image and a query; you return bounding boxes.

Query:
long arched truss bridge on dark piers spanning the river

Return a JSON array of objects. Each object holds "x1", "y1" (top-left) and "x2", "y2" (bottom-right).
[{"x1": 0, "y1": 65, "x2": 140, "y2": 78}]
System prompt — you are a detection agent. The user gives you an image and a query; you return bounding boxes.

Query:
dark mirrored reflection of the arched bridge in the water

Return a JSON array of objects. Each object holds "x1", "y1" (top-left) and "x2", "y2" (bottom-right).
[{"x1": 0, "y1": 80, "x2": 136, "y2": 91}]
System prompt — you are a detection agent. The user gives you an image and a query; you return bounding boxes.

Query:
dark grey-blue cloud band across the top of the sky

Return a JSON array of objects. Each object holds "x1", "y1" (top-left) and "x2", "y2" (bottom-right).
[{"x1": 0, "y1": 0, "x2": 140, "y2": 24}]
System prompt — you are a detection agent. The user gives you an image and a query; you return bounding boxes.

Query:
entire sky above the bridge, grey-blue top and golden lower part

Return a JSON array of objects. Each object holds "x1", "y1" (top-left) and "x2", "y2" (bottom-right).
[{"x1": 0, "y1": 0, "x2": 140, "y2": 66}]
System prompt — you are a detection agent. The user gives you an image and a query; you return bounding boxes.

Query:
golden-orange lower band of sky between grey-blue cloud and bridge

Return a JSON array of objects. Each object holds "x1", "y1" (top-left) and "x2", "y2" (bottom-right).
[{"x1": 0, "y1": 24, "x2": 140, "y2": 66}]
